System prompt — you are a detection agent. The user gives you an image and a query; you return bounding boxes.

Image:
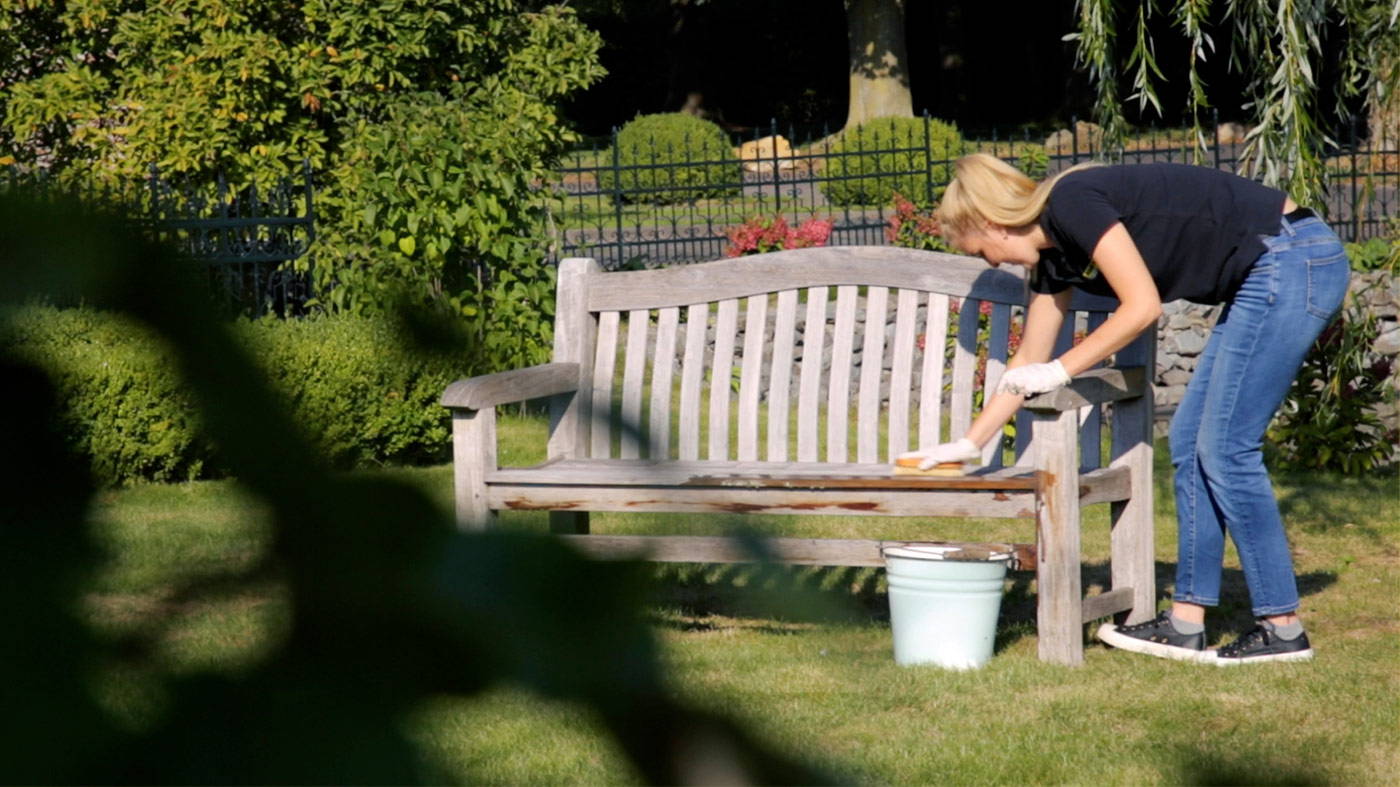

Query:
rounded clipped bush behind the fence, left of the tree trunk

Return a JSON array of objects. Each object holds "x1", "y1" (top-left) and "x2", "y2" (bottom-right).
[{"x1": 598, "y1": 112, "x2": 743, "y2": 204}]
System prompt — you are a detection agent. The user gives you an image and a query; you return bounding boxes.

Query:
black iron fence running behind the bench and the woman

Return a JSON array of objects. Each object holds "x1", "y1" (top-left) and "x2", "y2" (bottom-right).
[{"x1": 549, "y1": 110, "x2": 1400, "y2": 269}]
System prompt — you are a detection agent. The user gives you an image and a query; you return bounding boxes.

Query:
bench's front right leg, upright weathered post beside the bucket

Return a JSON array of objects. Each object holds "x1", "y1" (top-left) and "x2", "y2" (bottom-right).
[{"x1": 1032, "y1": 412, "x2": 1084, "y2": 664}]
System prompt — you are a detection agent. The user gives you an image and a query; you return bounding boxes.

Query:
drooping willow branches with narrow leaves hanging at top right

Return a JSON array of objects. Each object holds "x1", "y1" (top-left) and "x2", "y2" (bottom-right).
[{"x1": 1067, "y1": 0, "x2": 1400, "y2": 204}]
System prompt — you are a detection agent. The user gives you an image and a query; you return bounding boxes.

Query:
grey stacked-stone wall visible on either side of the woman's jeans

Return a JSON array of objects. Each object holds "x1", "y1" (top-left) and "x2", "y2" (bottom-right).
[{"x1": 1156, "y1": 270, "x2": 1400, "y2": 436}]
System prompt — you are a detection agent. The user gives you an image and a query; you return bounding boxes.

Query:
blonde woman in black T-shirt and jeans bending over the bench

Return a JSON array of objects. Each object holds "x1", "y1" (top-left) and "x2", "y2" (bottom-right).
[{"x1": 904, "y1": 154, "x2": 1350, "y2": 665}]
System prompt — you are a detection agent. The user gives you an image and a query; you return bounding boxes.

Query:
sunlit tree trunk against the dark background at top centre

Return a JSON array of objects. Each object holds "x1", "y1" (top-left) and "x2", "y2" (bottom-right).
[{"x1": 846, "y1": 0, "x2": 914, "y2": 129}]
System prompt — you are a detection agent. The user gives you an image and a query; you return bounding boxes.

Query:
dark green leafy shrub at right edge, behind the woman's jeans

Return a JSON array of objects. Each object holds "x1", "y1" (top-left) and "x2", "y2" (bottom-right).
[{"x1": 1268, "y1": 284, "x2": 1400, "y2": 475}]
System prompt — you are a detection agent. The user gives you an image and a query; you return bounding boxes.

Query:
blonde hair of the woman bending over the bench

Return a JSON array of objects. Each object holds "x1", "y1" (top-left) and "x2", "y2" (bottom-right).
[{"x1": 934, "y1": 153, "x2": 1102, "y2": 245}]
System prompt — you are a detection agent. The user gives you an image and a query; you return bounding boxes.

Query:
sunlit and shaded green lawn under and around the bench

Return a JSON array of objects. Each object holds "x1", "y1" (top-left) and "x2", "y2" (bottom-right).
[{"x1": 87, "y1": 417, "x2": 1400, "y2": 784}]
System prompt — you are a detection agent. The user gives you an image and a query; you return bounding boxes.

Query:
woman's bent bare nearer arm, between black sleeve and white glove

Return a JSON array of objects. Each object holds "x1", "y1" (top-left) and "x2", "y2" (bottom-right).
[{"x1": 1058, "y1": 221, "x2": 1162, "y2": 377}]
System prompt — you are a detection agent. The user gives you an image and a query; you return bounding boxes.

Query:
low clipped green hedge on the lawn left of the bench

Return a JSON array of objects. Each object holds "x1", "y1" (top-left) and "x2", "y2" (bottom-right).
[{"x1": 3, "y1": 307, "x2": 466, "y2": 485}]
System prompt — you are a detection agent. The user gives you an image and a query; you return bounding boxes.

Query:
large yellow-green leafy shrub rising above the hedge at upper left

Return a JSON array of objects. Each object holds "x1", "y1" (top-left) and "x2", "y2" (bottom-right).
[{"x1": 0, "y1": 0, "x2": 602, "y2": 365}]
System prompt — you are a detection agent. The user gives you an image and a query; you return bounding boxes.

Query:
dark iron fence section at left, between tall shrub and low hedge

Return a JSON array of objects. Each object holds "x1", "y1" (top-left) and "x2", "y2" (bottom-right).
[{"x1": 0, "y1": 164, "x2": 316, "y2": 316}]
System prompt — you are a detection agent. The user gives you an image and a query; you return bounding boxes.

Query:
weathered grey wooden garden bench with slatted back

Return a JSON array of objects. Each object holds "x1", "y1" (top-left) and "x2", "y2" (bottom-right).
[{"x1": 442, "y1": 246, "x2": 1156, "y2": 664}]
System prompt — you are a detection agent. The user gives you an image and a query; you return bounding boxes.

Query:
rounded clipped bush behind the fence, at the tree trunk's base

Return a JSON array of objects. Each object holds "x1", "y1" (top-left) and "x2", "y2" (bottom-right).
[{"x1": 822, "y1": 118, "x2": 962, "y2": 207}]
